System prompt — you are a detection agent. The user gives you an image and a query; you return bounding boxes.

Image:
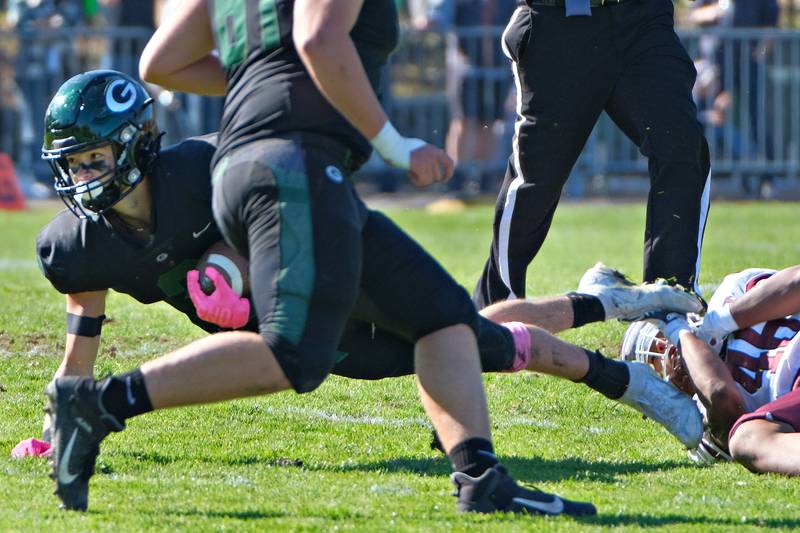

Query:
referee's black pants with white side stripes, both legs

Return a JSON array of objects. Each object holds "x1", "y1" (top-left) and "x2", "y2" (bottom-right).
[{"x1": 473, "y1": 0, "x2": 710, "y2": 308}]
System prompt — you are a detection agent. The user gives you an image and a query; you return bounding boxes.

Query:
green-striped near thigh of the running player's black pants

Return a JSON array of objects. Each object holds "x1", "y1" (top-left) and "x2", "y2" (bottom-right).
[{"x1": 213, "y1": 134, "x2": 366, "y2": 393}]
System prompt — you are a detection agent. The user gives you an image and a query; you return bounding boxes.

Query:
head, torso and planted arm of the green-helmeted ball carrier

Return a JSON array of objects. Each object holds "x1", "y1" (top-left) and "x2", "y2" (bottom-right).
[{"x1": 36, "y1": 70, "x2": 244, "y2": 375}]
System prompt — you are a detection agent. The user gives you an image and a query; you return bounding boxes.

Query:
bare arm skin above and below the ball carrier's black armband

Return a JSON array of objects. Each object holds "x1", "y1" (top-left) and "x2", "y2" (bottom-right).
[{"x1": 55, "y1": 291, "x2": 107, "y2": 377}]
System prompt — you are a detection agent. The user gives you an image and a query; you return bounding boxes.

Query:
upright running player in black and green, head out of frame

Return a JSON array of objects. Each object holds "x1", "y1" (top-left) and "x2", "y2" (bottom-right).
[{"x1": 40, "y1": 0, "x2": 696, "y2": 515}]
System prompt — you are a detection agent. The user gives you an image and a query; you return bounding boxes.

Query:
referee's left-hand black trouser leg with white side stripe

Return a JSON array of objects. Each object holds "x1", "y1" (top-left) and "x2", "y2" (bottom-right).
[{"x1": 473, "y1": 6, "x2": 619, "y2": 309}]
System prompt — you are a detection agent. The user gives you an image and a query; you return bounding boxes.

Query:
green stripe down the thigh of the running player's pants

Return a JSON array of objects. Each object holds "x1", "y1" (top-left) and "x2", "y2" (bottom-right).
[{"x1": 270, "y1": 163, "x2": 316, "y2": 345}]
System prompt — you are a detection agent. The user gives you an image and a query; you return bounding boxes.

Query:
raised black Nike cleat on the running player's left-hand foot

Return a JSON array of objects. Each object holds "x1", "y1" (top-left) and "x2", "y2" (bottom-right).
[{"x1": 45, "y1": 376, "x2": 125, "y2": 511}]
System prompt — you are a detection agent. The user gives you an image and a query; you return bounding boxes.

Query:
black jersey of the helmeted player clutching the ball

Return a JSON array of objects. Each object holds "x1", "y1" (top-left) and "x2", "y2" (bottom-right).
[{"x1": 36, "y1": 135, "x2": 247, "y2": 331}]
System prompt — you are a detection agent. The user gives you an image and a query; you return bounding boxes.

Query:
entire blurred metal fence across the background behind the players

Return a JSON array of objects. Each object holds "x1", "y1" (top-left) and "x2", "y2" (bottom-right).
[{"x1": 0, "y1": 27, "x2": 800, "y2": 196}]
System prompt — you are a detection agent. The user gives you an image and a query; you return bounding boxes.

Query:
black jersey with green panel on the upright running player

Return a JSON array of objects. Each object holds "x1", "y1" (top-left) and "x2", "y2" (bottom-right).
[{"x1": 208, "y1": 0, "x2": 399, "y2": 168}]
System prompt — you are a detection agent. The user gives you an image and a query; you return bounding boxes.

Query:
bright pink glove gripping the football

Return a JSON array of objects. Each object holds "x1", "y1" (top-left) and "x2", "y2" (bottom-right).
[{"x1": 186, "y1": 266, "x2": 250, "y2": 329}]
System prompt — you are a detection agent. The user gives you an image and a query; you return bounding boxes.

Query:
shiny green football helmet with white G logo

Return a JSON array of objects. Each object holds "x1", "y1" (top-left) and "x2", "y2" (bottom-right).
[{"x1": 42, "y1": 70, "x2": 161, "y2": 219}]
